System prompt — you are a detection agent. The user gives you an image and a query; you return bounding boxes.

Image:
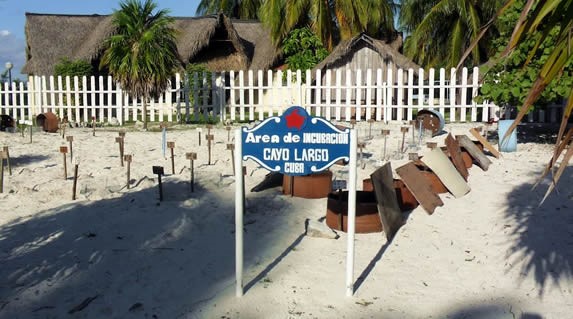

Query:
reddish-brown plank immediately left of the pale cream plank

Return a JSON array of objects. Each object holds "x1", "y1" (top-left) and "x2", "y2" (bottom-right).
[{"x1": 396, "y1": 162, "x2": 444, "y2": 214}]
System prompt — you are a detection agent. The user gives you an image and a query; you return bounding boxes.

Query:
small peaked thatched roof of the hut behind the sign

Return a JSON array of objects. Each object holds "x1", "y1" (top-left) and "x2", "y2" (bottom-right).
[{"x1": 314, "y1": 34, "x2": 420, "y2": 74}]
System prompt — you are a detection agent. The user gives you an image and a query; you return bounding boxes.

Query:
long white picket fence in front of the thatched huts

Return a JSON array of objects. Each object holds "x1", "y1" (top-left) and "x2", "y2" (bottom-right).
[{"x1": 0, "y1": 68, "x2": 562, "y2": 124}]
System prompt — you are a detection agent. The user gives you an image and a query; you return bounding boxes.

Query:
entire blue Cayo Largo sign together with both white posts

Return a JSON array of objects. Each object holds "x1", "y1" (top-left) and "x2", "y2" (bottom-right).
[{"x1": 234, "y1": 106, "x2": 357, "y2": 297}]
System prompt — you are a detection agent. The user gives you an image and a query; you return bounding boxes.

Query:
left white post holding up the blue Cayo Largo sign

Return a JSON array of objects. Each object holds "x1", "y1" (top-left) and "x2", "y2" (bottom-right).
[{"x1": 235, "y1": 128, "x2": 245, "y2": 297}]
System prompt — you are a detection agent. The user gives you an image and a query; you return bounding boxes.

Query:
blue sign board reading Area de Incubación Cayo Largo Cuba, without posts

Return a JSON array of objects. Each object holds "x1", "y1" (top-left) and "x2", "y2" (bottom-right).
[{"x1": 241, "y1": 106, "x2": 350, "y2": 175}]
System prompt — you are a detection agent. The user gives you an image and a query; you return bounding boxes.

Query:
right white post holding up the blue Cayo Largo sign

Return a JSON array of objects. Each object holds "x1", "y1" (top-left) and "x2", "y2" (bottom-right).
[{"x1": 346, "y1": 129, "x2": 357, "y2": 297}]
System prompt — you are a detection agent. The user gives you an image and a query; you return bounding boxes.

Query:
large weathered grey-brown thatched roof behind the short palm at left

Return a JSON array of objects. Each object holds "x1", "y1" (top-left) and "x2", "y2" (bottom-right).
[{"x1": 22, "y1": 13, "x2": 279, "y2": 75}]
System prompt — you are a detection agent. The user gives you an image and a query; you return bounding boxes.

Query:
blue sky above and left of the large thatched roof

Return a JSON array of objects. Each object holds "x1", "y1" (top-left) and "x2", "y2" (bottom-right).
[{"x1": 0, "y1": 0, "x2": 199, "y2": 79}]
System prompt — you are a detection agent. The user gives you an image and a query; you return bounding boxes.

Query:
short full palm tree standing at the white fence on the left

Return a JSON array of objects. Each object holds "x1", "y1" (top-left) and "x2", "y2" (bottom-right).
[{"x1": 100, "y1": 0, "x2": 180, "y2": 129}]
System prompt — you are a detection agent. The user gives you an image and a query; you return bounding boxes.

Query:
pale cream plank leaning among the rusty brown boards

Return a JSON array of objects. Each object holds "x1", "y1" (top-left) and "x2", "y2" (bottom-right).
[{"x1": 422, "y1": 148, "x2": 470, "y2": 198}]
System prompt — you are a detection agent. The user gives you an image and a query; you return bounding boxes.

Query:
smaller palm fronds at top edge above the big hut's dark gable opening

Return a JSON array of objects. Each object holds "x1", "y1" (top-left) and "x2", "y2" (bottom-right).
[{"x1": 196, "y1": 0, "x2": 263, "y2": 19}]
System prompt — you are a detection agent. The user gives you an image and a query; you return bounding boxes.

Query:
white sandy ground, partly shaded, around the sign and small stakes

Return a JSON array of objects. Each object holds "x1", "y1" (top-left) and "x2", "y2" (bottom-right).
[{"x1": 0, "y1": 123, "x2": 573, "y2": 318}]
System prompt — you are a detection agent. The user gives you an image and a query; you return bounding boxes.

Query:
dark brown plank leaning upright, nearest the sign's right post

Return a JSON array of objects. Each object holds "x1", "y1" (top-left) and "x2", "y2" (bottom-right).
[{"x1": 370, "y1": 162, "x2": 404, "y2": 241}]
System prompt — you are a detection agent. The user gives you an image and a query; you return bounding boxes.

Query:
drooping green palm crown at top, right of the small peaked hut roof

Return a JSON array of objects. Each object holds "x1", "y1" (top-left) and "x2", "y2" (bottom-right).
[{"x1": 400, "y1": 0, "x2": 501, "y2": 68}]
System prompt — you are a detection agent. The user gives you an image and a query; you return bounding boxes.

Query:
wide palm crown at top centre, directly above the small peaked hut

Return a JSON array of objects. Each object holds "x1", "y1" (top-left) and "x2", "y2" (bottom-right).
[{"x1": 260, "y1": 0, "x2": 395, "y2": 49}]
